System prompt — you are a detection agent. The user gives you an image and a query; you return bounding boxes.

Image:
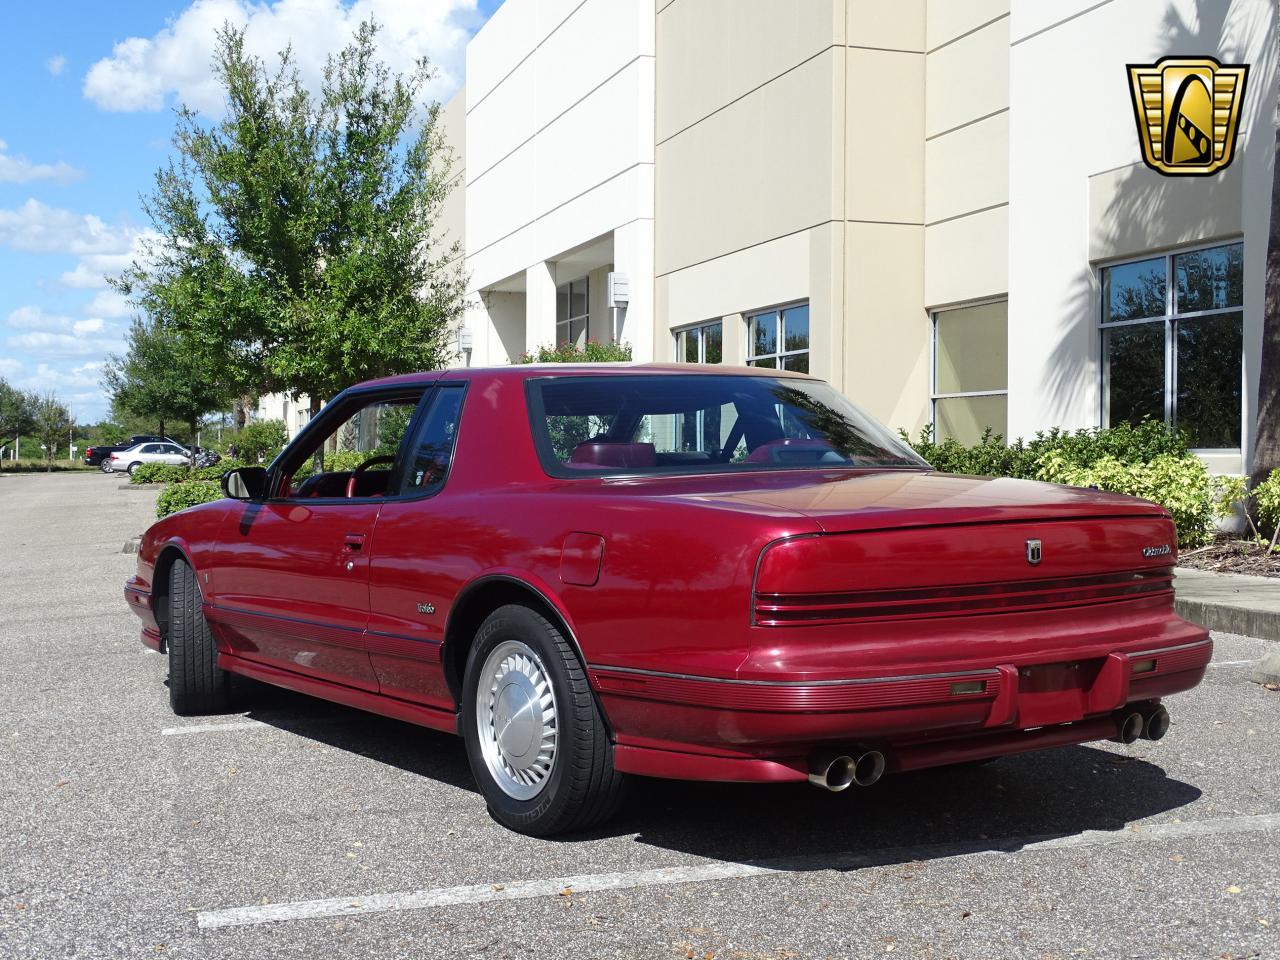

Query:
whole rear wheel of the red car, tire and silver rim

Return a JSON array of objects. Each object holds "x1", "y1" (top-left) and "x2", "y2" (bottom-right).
[{"x1": 462, "y1": 605, "x2": 625, "y2": 836}]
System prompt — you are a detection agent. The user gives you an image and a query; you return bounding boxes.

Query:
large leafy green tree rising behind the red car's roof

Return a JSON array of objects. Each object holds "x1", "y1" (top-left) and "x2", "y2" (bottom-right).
[{"x1": 115, "y1": 23, "x2": 465, "y2": 412}]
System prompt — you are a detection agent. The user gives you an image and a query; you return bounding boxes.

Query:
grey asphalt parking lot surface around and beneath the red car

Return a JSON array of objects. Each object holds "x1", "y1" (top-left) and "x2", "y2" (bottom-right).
[{"x1": 0, "y1": 474, "x2": 1280, "y2": 960}]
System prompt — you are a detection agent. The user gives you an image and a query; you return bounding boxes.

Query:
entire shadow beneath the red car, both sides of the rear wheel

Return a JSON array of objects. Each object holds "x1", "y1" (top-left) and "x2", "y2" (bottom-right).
[{"x1": 225, "y1": 682, "x2": 1201, "y2": 870}]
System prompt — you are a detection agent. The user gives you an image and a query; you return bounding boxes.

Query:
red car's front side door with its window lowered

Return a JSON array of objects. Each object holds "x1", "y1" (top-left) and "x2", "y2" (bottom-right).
[{"x1": 210, "y1": 387, "x2": 435, "y2": 691}]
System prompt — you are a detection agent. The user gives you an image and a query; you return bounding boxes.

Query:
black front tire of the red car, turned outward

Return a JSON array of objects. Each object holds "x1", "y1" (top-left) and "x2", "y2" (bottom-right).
[{"x1": 168, "y1": 559, "x2": 230, "y2": 717}]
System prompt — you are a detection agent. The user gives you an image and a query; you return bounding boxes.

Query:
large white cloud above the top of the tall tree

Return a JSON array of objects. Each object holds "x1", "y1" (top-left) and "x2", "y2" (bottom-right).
[{"x1": 83, "y1": 0, "x2": 479, "y2": 114}]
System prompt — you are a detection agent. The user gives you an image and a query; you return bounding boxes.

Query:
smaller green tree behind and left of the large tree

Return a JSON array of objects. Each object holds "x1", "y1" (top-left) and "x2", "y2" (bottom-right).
[{"x1": 102, "y1": 319, "x2": 233, "y2": 463}]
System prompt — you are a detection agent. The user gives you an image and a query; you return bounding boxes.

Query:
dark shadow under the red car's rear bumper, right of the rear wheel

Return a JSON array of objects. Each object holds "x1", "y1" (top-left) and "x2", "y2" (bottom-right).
[{"x1": 605, "y1": 746, "x2": 1201, "y2": 870}]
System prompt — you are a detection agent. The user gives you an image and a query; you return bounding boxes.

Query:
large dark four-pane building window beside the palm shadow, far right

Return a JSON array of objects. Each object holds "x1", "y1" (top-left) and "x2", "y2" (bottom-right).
[{"x1": 1102, "y1": 243, "x2": 1244, "y2": 451}]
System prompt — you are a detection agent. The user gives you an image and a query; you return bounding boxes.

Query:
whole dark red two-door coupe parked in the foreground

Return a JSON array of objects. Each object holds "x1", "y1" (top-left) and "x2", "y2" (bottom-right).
[{"x1": 124, "y1": 365, "x2": 1212, "y2": 835}]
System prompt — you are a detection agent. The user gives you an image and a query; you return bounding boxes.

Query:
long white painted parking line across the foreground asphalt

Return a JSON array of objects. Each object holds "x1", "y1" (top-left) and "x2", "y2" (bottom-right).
[{"x1": 196, "y1": 814, "x2": 1280, "y2": 929}]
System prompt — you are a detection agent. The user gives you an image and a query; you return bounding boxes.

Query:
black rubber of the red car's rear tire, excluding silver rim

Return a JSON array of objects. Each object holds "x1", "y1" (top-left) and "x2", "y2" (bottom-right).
[{"x1": 461, "y1": 604, "x2": 626, "y2": 837}]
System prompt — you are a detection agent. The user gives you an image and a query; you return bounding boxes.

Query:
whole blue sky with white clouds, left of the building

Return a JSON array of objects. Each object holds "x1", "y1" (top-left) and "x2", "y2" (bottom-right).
[{"x1": 0, "y1": 0, "x2": 500, "y2": 422}]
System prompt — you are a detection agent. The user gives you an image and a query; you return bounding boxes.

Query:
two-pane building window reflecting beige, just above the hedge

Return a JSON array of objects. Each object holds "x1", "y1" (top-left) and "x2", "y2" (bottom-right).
[{"x1": 933, "y1": 300, "x2": 1009, "y2": 445}]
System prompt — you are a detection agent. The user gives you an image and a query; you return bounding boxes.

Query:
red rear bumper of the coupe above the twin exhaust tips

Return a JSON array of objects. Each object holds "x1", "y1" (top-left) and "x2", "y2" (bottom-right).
[{"x1": 590, "y1": 632, "x2": 1213, "y2": 781}]
